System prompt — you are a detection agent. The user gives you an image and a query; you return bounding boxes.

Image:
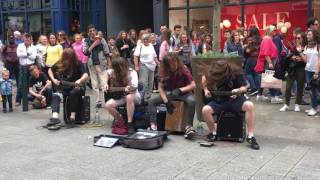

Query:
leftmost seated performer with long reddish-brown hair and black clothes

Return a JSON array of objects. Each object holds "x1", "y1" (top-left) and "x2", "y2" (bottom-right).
[{"x1": 47, "y1": 48, "x2": 89, "y2": 128}]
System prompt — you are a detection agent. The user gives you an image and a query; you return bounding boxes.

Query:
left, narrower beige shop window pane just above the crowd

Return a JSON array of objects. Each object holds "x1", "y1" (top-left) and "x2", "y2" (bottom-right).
[{"x1": 169, "y1": 10, "x2": 187, "y2": 30}]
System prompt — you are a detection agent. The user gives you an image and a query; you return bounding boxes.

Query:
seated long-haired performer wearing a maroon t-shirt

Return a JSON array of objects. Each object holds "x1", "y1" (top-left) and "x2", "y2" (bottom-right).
[{"x1": 148, "y1": 53, "x2": 196, "y2": 139}]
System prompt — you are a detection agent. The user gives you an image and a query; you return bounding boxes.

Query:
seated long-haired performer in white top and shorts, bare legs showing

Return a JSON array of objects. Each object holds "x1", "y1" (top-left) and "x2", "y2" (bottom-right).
[{"x1": 105, "y1": 57, "x2": 141, "y2": 134}]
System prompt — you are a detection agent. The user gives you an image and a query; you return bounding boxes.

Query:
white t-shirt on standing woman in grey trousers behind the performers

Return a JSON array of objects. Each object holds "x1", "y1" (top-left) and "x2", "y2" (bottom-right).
[{"x1": 133, "y1": 43, "x2": 157, "y2": 71}]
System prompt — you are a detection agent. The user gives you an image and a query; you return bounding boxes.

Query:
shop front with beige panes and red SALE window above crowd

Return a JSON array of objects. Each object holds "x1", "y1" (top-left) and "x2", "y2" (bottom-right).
[{"x1": 169, "y1": 0, "x2": 320, "y2": 39}]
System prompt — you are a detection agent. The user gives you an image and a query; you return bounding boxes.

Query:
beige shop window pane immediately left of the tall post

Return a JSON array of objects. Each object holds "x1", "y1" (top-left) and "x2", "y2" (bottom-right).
[{"x1": 189, "y1": 8, "x2": 213, "y2": 32}]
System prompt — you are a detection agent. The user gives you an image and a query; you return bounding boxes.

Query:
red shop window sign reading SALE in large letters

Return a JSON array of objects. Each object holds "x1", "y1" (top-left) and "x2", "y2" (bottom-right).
[{"x1": 221, "y1": 0, "x2": 308, "y2": 45}]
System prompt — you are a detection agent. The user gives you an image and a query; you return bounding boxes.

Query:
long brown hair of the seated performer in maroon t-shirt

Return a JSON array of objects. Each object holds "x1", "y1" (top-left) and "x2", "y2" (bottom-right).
[{"x1": 160, "y1": 52, "x2": 184, "y2": 81}]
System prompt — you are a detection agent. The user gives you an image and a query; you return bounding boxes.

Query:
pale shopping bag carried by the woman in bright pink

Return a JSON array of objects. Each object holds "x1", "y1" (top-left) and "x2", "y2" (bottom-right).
[{"x1": 261, "y1": 70, "x2": 282, "y2": 89}]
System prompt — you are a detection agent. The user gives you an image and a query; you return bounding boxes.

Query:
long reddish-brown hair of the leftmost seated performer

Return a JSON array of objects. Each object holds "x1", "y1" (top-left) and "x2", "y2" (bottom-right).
[{"x1": 56, "y1": 48, "x2": 79, "y2": 74}]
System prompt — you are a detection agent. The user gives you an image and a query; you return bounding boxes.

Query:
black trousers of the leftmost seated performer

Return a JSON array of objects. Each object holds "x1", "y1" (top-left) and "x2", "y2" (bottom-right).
[{"x1": 51, "y1": 88, "x2": 84, "y2": 113}]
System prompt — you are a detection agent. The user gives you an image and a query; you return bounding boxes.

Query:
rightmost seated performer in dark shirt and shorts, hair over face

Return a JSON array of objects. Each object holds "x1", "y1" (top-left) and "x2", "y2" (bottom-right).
[{"x1": 202, "y1": 61, "x2": 260, "y2": 150}]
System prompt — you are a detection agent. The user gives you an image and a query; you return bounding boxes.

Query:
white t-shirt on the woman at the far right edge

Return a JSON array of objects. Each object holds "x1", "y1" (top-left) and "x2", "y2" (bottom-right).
[{"x1": 303, "y1": 46, "x2": 320, "y2": 72}]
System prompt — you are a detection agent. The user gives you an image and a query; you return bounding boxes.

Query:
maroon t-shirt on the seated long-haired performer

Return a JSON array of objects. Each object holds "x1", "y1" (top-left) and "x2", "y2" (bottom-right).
[{"x1": 164, "y1": 67, "x2": 193, "y2": 91}]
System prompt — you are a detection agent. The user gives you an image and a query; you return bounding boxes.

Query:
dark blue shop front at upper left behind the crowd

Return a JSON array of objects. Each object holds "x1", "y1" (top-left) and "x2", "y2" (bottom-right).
[{"x1": 0, "y1": 0, "x2": 101, "y2": 40}]
